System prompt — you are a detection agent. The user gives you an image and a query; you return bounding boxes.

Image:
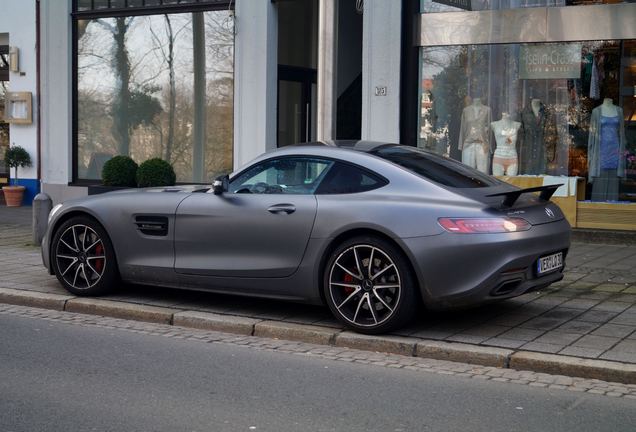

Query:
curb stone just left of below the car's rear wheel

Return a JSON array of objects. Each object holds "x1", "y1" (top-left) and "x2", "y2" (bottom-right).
[{"x1": 254, "y1": 321, "x2": 340, "y2": 345}]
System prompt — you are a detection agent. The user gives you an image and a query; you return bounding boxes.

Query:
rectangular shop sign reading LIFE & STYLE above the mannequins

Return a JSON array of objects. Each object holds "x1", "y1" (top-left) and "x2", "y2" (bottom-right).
[{"x1": 519, "y1": 43, "x2": 581, "y2": 79}]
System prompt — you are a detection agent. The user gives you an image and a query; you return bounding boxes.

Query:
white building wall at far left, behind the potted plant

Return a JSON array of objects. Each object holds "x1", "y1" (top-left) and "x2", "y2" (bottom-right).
[{"x1": 0, "y1": 0, "x2": 38, "y2": 188}]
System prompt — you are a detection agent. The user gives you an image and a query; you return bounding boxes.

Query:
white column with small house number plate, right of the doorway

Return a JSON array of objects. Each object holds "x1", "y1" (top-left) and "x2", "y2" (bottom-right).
[{"x1": 362, "y1": 0, "x2": 402, "y2": 142}]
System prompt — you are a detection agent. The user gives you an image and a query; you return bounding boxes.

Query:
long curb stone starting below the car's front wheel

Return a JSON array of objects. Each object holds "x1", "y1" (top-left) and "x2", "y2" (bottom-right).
[{"x1": 64, "y1": 298, "x2": 179, "y2": 324}]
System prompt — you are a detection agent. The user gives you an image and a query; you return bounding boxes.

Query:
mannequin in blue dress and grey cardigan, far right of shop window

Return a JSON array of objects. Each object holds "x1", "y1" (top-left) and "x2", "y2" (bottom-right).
[{"x1": 587, "y1": 98, "x2": 625, "y2": 201}]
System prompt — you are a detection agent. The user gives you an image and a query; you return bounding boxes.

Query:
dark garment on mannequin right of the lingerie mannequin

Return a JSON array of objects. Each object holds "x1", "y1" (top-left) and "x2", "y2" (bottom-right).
[{"x1": 519, "y1": 103, "x2": 548, "y2": 175}]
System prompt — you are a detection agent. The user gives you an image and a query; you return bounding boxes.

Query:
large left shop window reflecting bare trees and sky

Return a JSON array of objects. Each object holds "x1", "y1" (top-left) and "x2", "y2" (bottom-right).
[{"x1": 76, "y1": 10, "x2": 234, "y2": 182}]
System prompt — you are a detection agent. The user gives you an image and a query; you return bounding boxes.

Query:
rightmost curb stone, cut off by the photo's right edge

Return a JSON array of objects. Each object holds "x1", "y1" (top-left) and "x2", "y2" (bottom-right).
[{"x1": 510, "y1": 351, "x2": 636, "y2": 384}]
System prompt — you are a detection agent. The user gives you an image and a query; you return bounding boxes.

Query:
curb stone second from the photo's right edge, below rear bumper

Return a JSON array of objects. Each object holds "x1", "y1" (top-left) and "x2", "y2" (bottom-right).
[{"x1": 415, "y1": 340, "x2": 514, "y2": 368}]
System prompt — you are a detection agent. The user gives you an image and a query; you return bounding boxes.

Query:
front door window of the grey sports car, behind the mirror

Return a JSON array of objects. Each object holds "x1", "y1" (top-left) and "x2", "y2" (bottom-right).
[{"x1": 230, "y1": 157, "x2": 333, "y2": 195}]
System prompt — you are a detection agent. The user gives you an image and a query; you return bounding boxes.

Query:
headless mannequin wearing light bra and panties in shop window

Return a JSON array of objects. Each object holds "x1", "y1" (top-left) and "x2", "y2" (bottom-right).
[{"x1": 490, "y1": 113, "x2": 521, "y2": 175}]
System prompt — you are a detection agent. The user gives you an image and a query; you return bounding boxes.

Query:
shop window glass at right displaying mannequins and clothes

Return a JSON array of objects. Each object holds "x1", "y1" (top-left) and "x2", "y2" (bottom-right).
[{"x1": 418, "y1": 40, "x2": 636, "y2": 202}]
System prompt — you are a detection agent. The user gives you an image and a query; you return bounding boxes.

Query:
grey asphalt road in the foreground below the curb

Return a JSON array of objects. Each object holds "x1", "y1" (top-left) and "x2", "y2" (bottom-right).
[{"x1": 0, "y1": 315, "x2": 636, "y2": 432}]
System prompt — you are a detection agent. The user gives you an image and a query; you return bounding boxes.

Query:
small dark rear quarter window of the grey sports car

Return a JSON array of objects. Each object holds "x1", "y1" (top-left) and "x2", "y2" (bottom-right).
[{"x1": 316, "y1": 163, "x2": 387, "y2": 195}]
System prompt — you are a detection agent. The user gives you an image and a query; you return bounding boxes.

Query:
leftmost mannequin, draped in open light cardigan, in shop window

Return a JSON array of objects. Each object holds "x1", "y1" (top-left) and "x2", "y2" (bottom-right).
[{"x1": 457, "y1": 98, "x2": 492, "y2": 174}]
